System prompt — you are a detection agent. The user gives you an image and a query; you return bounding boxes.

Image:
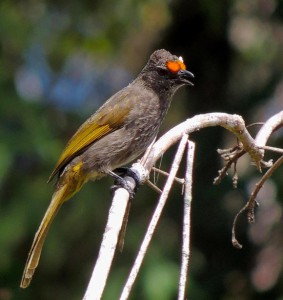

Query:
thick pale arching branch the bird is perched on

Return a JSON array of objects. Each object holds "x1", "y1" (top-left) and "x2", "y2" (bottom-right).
[{"x1": 84, "y1": 113, "x2": 280, "y2": 300}]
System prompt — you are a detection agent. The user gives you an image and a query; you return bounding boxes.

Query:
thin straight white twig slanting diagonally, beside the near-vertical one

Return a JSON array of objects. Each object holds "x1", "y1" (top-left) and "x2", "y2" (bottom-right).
[{"x1": 120, "y1": 134, "x2": 188, "y2": 300}]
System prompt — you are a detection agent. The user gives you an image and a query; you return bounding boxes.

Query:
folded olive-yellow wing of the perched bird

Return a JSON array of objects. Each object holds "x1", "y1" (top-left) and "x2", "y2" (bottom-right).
[{"x1": 48, "y1": 95, "x2": 131, "y2": 182}]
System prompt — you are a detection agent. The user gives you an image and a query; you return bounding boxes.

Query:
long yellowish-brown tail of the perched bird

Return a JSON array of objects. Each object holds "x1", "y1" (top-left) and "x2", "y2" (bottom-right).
[{"x1": 20, "y1": 184, "x2": 77, "y2": 288}]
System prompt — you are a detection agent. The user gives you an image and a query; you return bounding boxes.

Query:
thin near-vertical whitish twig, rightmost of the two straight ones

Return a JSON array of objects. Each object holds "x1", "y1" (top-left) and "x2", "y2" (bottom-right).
[{"x1": 178, "y1": 141, "x2": 195, "y2": 300}]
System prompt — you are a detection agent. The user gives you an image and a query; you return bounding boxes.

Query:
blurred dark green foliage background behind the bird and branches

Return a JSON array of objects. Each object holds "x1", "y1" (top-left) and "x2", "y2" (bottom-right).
[{"x1": 0, "y1": 0, "x2": 283, "y2": 300}]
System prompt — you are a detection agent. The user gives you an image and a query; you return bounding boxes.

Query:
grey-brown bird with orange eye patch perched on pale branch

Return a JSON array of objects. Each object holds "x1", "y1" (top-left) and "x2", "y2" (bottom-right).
[{"x1": 21, "y1": 49, "x2": 194, "y2": 288}]
